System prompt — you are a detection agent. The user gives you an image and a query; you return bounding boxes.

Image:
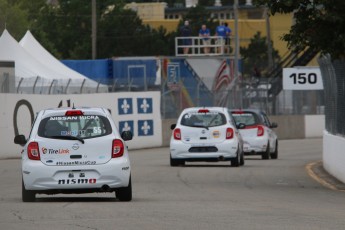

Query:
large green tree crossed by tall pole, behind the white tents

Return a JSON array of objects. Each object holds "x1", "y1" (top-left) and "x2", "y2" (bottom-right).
[{"x1": 27, "y1": 0, "x2": 175, "y2": 59}]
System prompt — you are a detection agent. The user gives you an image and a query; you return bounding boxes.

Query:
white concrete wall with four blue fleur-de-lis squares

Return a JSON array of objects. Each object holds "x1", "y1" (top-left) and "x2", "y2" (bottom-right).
[{"x1": 0, "y1": 91, "x2": 162, "y2": 158}]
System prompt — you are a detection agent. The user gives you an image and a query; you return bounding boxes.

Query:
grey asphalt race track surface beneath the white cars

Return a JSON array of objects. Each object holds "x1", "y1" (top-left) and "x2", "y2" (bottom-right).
[{"x1": 0, "y1": 139, "x2": 345, "y2": 230}]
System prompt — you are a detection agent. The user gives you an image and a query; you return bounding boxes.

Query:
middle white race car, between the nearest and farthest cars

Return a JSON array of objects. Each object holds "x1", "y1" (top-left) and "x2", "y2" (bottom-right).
[{"x1": 170, "y1": 107, "x2": 244, "y2": 167}]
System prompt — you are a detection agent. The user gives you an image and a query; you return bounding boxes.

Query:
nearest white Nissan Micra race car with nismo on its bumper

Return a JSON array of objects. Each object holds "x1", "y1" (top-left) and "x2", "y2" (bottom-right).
[{"x1": 14, "y1": 107, "x2": 132, "y2": 202}]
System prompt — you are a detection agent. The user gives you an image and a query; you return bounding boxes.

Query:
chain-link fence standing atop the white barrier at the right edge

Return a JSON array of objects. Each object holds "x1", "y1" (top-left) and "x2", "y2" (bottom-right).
[{"x1": 319, "y1": 55, "x2": 345, "y2": 135}]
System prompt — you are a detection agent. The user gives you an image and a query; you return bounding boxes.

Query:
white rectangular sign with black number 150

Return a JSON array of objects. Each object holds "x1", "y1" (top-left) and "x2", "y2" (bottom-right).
[{"x1": 283, "y1": 67, "x2": 323, "y2": 90}]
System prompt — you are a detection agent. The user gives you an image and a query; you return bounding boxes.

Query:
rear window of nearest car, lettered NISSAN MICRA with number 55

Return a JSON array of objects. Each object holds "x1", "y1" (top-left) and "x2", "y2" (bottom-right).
[{"x1": 38, "y1": 115, "x2": 112, "y2": 139}]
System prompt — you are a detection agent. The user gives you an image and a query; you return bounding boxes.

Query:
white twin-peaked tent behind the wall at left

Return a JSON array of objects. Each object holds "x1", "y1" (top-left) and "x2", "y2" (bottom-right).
[{"x1": 0, "y1": 29, "x2": 107, "y2": 93}]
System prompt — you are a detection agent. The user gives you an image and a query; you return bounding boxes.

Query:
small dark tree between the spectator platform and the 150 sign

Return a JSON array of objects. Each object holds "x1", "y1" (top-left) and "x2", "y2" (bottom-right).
[{"x1": 240, "y1": 32, "x2": 280, "y2": 78}]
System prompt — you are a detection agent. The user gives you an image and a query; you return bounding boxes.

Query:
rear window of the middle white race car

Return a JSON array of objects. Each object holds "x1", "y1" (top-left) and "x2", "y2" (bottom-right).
[{"x1": 181, "y1": 112, "x2": 226, "y2": 127}]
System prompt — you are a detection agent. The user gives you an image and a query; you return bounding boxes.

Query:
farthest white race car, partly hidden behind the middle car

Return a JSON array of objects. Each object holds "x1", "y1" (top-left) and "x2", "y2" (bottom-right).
[{"x1": 231, "y1": 109, "x2": 278, "y2": 159}]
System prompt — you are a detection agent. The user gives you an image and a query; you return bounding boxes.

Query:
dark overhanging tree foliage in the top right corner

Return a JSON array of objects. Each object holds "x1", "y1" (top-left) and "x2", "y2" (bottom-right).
[{"x1": 254, "y1": 0, "x2": 345, "y2": 59}]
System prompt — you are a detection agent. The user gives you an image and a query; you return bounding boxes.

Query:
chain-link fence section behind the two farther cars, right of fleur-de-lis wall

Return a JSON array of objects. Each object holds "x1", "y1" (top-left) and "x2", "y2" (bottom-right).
[{"x1": 161, "y1": 79, "x2": 325, "y2": 118}]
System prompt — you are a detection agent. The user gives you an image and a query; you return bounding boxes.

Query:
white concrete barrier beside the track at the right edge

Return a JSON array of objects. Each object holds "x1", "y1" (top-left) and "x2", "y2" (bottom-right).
[{"x1": 322, "y1": 131, "x2": 345, "y2": 183}]
